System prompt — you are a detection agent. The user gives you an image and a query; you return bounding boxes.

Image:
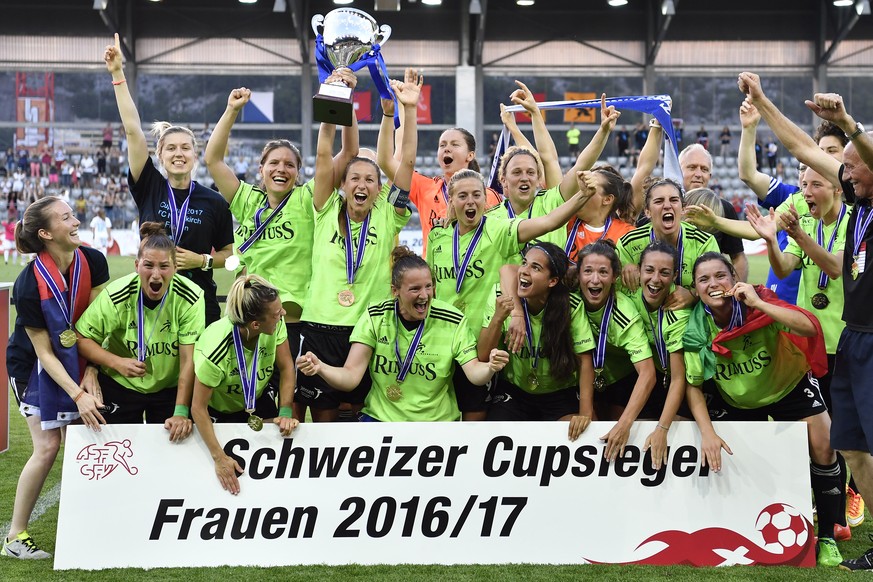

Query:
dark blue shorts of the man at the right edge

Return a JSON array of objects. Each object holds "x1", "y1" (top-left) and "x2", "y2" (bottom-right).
[{"x1": 831, "y1": 328, "x2": 873, "y2": 453}]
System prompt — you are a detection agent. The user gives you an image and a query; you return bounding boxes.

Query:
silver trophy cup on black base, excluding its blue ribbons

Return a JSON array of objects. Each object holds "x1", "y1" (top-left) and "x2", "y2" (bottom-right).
[{"x1": 312, "y1": 8, "x2": 391, "y2": 126}]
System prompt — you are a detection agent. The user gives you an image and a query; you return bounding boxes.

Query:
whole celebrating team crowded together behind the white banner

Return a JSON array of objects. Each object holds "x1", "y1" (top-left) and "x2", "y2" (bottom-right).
[{"x1": 3, "y1": 36, "x2": 873, "y2": 565}]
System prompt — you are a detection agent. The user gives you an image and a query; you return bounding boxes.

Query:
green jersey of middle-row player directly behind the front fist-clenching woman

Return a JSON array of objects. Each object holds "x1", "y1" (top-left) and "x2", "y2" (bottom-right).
[{"x1": 427, "y1": 214, "x2": 523, "y2": 337}]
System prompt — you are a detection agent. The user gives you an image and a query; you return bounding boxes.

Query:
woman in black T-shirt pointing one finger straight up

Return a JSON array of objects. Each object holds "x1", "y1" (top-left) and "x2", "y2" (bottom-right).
[{"x1": 103, "y1": 34, "x2": 233, "y2": 323}]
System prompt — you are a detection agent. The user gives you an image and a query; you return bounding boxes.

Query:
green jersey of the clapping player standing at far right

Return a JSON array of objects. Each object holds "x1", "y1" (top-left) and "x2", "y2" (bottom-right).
[{"x1": 785, "y1": 208, "x2": 851, "y2": 354}]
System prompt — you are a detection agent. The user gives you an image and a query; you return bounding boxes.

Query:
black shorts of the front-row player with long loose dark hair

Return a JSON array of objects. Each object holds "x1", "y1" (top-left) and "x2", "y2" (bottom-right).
[{"x1": 488, "y1": 381, "x2": 579, "y2": 420}]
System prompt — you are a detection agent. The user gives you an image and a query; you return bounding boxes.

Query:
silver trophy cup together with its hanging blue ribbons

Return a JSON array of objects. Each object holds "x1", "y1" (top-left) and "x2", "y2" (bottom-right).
[{"x1": 312, "y1": 8, "x2": 400, "y2": 127}]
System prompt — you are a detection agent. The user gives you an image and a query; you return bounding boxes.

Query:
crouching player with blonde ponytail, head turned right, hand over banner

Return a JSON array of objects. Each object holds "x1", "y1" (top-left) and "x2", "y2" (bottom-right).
[{"x1": 191, "y1": 275, "x2": 298, "y2": 495}]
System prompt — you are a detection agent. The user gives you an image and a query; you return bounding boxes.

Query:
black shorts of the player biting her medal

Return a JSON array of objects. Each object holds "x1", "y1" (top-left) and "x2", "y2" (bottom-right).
[{"x1": 702, "y1": 372, "x2": 828, "y2": 421}]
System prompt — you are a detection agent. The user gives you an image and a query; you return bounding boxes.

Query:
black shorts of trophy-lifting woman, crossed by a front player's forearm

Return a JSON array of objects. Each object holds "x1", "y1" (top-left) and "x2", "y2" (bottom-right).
[{"x1": 294, "y1": 322, "x2": 371, "y2": 410}]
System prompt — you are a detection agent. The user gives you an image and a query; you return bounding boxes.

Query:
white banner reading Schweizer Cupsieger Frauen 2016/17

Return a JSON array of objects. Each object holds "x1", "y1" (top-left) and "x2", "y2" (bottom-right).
[{"x1": 55, "y1": 422, "x2": 815, "y2": 569}]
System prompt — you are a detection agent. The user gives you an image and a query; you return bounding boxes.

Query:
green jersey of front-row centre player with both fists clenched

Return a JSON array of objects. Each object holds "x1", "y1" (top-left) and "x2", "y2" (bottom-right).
[{"x1": 350, "y1": 299, "x2": 476, "y2": 422}]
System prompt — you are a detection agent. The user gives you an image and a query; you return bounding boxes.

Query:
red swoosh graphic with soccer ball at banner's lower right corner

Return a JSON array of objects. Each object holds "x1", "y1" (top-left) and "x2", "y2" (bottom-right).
[{"x1": 586, "y1": 503, "x2": 815, "y2": 567}]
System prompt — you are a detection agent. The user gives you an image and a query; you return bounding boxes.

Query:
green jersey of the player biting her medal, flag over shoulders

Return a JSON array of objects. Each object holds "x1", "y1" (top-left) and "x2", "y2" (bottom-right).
[{"x1": 685, "y1": 318, "x2": 809, "y2": 409}]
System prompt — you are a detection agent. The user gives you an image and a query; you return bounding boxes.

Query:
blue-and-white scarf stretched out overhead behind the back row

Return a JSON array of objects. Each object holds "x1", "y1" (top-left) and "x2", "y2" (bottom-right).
[{"x1": 488, "y1": 95, "x2": 682, "y2": 188}]
